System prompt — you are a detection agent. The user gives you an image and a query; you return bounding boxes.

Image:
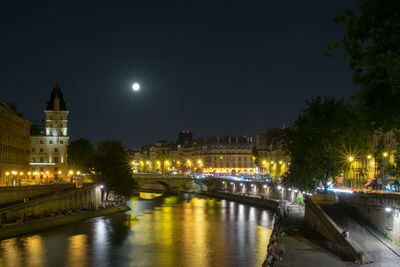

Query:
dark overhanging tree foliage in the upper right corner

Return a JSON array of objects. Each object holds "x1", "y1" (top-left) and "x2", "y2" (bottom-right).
[{"x1": 328, "y1": 0, "x2": 400, "y2": 131}]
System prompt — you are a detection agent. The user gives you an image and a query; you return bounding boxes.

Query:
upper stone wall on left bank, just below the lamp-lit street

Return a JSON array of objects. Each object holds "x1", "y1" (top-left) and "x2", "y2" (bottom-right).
[{"x1": 0, "y1": 184, "x2": 75, "y2": 206}]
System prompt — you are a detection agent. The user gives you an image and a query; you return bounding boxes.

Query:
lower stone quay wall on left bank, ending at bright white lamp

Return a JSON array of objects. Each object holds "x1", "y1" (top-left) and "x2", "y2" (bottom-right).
[{"x1": 0, "y1": 185, "x2": 101, "y2": 223}]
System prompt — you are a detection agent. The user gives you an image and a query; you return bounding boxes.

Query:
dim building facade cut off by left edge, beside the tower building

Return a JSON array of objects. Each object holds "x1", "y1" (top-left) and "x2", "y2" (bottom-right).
[{"x1": 0, "y1": 102, "x2": 31, "y2": 185}]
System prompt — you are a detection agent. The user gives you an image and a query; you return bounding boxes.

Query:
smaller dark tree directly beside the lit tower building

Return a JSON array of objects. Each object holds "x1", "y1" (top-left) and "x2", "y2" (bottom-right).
[{"x1": 68, "y1": 138, "x2": 95, "y2": 172}]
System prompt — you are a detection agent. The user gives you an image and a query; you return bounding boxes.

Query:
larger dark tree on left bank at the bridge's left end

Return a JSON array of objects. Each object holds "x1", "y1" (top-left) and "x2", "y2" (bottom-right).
[{"x1": 91, "y1": 140, "x2": 136, "y2": 199}]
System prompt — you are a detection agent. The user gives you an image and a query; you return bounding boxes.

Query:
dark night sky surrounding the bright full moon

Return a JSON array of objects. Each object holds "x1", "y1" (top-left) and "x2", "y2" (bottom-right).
[{"x1": 0, "y1": 0, "x2": 358, "y2": 147}]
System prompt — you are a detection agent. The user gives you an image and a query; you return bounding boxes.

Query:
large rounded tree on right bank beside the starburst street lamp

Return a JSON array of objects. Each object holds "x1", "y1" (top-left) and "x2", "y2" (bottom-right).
[{"x1": 284, "y1": 97, "x2": 371, "y2": 190}]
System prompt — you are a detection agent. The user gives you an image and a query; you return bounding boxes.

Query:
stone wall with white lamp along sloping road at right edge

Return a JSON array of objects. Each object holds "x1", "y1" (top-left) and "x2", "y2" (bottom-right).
[{"x1": 339, "y1": 192, "x2": 400, "y2": 246}]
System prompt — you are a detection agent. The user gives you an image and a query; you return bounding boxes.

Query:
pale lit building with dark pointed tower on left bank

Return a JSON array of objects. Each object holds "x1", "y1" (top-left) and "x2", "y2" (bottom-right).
[{"x1": 29, "y1": 81, "x2": 69, "y2": 183}]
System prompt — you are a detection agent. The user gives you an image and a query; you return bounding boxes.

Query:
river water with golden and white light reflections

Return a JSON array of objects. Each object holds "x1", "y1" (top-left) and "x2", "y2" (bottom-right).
[{"x1": 0, "y1": 194, "x2": 273, "y2": 267}]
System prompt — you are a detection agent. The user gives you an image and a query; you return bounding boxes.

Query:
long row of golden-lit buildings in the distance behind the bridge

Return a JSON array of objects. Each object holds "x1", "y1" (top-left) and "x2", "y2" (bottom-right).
[{"x1": 132, "y1": 131, "x2": 255, "y2": 174}]
